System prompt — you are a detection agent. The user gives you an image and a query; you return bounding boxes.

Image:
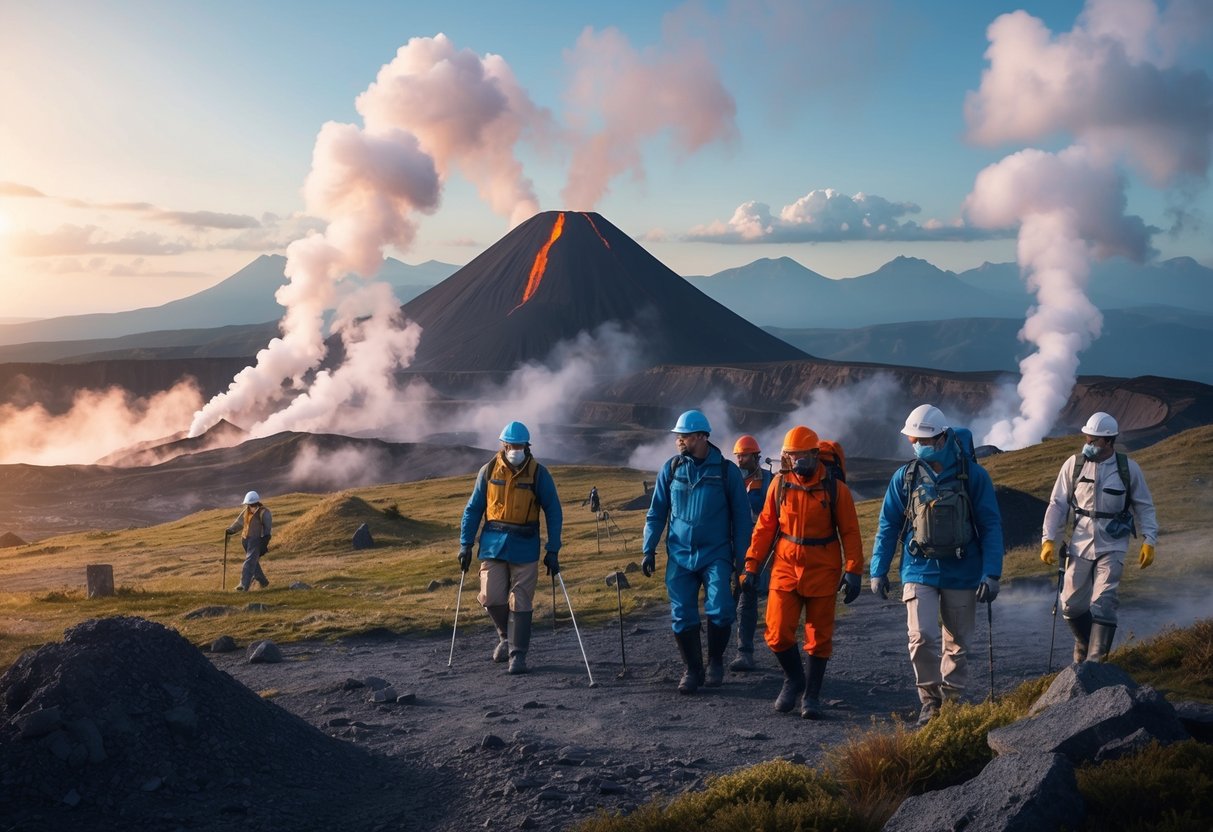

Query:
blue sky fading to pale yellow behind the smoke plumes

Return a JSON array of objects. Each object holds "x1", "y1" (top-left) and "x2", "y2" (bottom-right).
[{"x1": 0, "y1": 0, "x2": 1213, "y2": 318}]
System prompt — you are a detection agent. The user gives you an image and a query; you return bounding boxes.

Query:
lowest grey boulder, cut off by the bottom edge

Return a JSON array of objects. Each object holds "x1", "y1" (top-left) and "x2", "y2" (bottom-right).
[{"x1": 883, "y1": 754, "x2": 1084, "y2": 832}]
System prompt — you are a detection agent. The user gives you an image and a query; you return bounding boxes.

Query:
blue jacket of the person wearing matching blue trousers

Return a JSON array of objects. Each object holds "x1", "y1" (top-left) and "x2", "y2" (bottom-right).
[{"x1": 642, "y1": 445, "x2": 753, "y2": 571}]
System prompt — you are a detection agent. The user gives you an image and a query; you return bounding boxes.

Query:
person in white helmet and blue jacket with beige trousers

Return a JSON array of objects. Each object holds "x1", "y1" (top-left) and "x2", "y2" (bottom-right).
[{"x1": 871, "y1": 404, "x2": 1003, "y2": 725}]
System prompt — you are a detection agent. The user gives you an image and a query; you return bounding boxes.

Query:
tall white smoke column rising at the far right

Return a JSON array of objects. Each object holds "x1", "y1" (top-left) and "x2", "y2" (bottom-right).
[{"x1": 966, "y1": 0, "x2": 1213, "y2": 448}]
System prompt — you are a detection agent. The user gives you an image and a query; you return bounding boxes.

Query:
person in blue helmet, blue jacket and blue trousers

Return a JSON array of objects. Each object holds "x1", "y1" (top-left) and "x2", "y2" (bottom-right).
[{"x1": 640, "y1": 410, "x2": 753, "y2": 694}]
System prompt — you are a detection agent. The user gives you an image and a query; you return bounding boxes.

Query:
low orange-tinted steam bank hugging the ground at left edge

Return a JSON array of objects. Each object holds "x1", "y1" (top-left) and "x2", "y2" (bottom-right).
[{"x1": 0, "y1": 381, "x2": 203, "y2": 466}]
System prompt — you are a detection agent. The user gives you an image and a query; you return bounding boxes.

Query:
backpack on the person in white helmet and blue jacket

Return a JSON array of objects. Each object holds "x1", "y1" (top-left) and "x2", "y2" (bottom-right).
[{"x1": 899, "y1": 428, "x2": 978, "y2": 558}]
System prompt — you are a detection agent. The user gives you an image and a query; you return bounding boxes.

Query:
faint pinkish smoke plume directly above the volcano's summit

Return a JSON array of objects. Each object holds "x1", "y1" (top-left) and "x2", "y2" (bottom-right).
[{"x1": 562, "y1": 28, "x2": 738, "y2": 211}]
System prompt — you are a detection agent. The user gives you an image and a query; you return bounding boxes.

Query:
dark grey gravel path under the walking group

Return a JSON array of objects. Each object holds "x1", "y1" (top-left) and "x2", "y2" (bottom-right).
[{"x1": 203, "y1": 582, "x2": 1200, "y2": 831}]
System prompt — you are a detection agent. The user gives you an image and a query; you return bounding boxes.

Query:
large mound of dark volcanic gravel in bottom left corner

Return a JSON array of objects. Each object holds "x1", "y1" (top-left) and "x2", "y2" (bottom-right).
[{"x1": 0, "y1": 619, "x2": 436, "y2": 830}]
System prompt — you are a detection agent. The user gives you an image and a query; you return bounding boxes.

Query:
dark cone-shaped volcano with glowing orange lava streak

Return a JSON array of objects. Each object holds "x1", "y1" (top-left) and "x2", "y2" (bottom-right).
[{"x1": 404, "y1": 211, "x2": 808, "y2": 371}]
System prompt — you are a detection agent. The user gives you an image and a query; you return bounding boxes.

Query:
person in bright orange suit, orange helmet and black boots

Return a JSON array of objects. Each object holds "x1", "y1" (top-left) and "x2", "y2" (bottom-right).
[{"x1": 741, "y1": 424, "x2": 864, "y2": 719}]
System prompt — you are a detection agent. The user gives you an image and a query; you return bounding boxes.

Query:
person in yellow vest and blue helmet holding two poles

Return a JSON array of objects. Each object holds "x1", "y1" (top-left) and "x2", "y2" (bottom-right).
[{"x1": 459, "y1": 422, "x2": 564, "y2": 673}]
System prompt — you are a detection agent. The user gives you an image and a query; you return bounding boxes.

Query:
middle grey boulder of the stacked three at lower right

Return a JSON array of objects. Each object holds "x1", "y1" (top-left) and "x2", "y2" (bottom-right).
[{"x1": 986, "y1": 685, "x2": 1188, "y2": 763}]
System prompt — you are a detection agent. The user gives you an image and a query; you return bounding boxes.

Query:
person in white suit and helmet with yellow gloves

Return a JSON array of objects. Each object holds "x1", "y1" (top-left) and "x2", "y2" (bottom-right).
[{"x1": 1041, "y1": 412, "x2": 1158, "y2": 662}]
